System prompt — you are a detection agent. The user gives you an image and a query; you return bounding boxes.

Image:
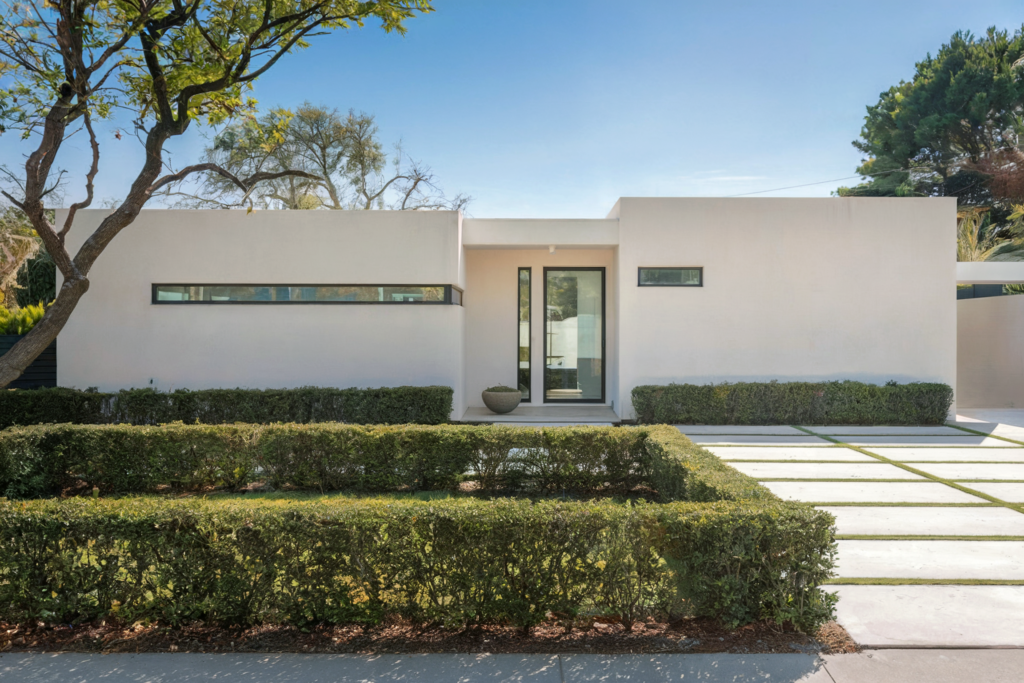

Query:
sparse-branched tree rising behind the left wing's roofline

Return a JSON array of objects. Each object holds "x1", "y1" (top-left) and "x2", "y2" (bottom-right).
[{"x1": 177, "y1": 102, "x2": 469, "y2": 210}]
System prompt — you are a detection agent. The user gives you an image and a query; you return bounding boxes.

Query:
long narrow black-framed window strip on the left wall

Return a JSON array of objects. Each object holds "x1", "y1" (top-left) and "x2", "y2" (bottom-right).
[{"x1": 153, "y1": 285, "x2": 462, "y2": 306}]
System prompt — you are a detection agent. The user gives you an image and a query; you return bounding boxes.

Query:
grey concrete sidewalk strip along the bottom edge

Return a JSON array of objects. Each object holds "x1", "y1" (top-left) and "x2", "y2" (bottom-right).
[{"x1": 6, "y1": 649, "x2": 1024, "y2": 683}]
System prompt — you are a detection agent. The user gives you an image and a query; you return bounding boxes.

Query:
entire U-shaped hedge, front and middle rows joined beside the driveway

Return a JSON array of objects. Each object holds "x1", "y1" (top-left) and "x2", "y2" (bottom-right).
[{"x1": 0, "y1": 424, "x2": 836, "y2": 630}]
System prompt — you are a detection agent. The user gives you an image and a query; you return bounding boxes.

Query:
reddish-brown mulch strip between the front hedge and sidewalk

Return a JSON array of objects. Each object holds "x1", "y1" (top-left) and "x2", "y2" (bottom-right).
[{"x1": 0, "y1": 618, "x2": 857, "y2": 654}]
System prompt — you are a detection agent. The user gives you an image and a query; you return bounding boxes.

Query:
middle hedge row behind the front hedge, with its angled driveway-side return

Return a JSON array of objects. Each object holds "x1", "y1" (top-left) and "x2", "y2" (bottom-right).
[{"x1": 0, "y1": 423, "x2": 770, "y2": 501}]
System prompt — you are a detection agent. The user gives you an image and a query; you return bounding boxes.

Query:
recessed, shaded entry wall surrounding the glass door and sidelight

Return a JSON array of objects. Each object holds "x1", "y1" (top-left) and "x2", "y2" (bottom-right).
[{"x1": 465, "y1": 248, "x2": 617, "y2": 409}]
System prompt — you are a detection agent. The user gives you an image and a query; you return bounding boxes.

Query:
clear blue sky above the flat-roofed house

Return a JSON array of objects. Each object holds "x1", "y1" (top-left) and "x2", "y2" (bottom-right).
[{"x1": 0, "y1": 0, "x2": 1024, "y2": 217}]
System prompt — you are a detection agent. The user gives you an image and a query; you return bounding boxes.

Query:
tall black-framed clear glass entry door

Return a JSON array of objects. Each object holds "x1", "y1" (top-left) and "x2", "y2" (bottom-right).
[{"x1": 544, "y1": 268, "x2": 604, "y2": 403}]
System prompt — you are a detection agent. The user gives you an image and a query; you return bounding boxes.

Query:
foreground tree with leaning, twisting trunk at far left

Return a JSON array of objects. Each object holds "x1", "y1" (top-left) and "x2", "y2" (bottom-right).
[{"x1": 0, "y1": 0, "x2": 432, "y2": 387}]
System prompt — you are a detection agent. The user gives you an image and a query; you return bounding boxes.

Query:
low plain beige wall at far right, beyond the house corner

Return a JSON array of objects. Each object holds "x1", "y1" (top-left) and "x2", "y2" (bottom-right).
[{"x1": 956, "y1": 295, "x2": 1024, "y2": 408}]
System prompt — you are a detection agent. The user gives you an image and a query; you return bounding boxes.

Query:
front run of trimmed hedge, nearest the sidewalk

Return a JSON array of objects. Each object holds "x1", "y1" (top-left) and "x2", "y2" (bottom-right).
[{"x1": 0, "y1": 495, "x2": 835, "y2": 630}]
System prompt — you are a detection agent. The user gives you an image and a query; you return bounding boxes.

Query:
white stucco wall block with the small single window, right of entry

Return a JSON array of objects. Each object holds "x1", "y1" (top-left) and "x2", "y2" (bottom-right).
[{"x1": 612, "y1": 198, "x2": 956, "y2": 418}]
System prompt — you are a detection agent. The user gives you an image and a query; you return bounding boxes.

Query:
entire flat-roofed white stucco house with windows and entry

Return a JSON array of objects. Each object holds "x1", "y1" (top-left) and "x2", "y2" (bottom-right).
[{"x1": 57, "y1": 198, "x2": 956, "y2": 420}]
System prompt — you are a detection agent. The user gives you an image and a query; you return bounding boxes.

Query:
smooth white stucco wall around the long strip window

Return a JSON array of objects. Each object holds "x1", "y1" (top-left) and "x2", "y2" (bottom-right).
[{"x1": 57, "y1": 210, "x2": 465, "y2": 419}]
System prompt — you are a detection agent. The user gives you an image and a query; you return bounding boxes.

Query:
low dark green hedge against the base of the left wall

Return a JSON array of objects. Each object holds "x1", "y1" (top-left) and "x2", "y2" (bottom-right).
[{"x1": 0, "y1": 386, "x2": 453, "y2": 429}]
